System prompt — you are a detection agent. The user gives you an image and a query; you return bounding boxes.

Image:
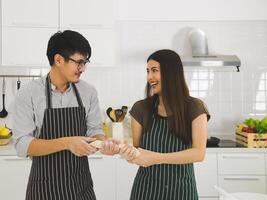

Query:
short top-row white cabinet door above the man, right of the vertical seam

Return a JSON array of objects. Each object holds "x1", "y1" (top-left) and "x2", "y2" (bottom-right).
[{"x1": 60, "y1": 0, "x2": 114, "y2": 29}]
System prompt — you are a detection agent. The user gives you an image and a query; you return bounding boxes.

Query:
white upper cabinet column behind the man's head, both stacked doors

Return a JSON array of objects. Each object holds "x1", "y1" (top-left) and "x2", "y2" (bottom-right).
[{"x1": 59, "y1": 0, "x2": 115, "y2": 66}]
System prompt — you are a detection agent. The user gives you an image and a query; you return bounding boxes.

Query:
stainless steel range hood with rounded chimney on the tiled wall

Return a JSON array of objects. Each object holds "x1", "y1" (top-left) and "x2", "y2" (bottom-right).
[{"x1": 181, "y1": 29, "x2": 241, "y2": 72}]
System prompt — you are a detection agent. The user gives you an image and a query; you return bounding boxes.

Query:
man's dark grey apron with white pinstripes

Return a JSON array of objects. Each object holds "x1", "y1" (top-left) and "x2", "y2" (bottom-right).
[{"x1": 26, "y1": 75, "x2": 96, "y2": 200}]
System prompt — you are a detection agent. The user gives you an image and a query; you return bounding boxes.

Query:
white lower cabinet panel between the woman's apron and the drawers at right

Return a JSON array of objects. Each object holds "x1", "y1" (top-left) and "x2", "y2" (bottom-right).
[{"x1": 194, "y1": 153, "x2": 218, "y2": 198}]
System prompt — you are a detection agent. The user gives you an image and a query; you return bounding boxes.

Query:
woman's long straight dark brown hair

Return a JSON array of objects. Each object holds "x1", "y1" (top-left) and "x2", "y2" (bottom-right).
[{"x1": 146, "y1": 49, "x2": 192, "y2": 143}]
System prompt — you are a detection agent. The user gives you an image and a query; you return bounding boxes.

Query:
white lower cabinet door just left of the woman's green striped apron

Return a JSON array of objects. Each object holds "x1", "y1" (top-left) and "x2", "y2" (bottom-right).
[{"x1": 116, "y1": 158, "x2": 138, "y2": 200}]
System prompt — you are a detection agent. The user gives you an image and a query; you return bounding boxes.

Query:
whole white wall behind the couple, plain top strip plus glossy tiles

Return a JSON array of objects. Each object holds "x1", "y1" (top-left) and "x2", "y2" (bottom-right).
[{"x1": 0, "y1": 0, "x2": 267, "y2": 138}]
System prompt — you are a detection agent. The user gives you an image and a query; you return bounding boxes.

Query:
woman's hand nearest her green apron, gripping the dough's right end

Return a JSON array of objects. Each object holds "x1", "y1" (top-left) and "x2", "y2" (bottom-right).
[{"x1": 129, "y1": 148, "x2": 160, "y2": 167}]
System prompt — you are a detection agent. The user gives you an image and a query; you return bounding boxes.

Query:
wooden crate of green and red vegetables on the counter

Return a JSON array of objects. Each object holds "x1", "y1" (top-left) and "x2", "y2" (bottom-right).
[{"x1": 235, "y1": 117, "x2": 267, "y2": 148}]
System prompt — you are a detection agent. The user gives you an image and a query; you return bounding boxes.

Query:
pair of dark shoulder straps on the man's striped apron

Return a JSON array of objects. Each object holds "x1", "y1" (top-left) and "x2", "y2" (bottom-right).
[{"x1": 45, "y1": 73, "x2": 83, "y2": 109}]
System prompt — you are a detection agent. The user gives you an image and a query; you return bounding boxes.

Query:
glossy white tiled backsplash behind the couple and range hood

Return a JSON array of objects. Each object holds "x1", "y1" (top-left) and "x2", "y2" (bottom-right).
[{"x1": 0, "y1": 21, "x2": 267, "y2": 135}]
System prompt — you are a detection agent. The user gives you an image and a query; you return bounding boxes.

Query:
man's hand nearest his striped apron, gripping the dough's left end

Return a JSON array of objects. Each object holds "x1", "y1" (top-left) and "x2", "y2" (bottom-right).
[{"x1": 66, "y1": 136, "x2": 97, "y2": 156}]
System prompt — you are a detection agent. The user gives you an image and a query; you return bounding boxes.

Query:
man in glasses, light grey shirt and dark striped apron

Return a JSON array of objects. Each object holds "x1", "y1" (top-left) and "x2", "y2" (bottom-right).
[{"x1": 13, "y1": 30, "x2": 118, "y2": 200}]
